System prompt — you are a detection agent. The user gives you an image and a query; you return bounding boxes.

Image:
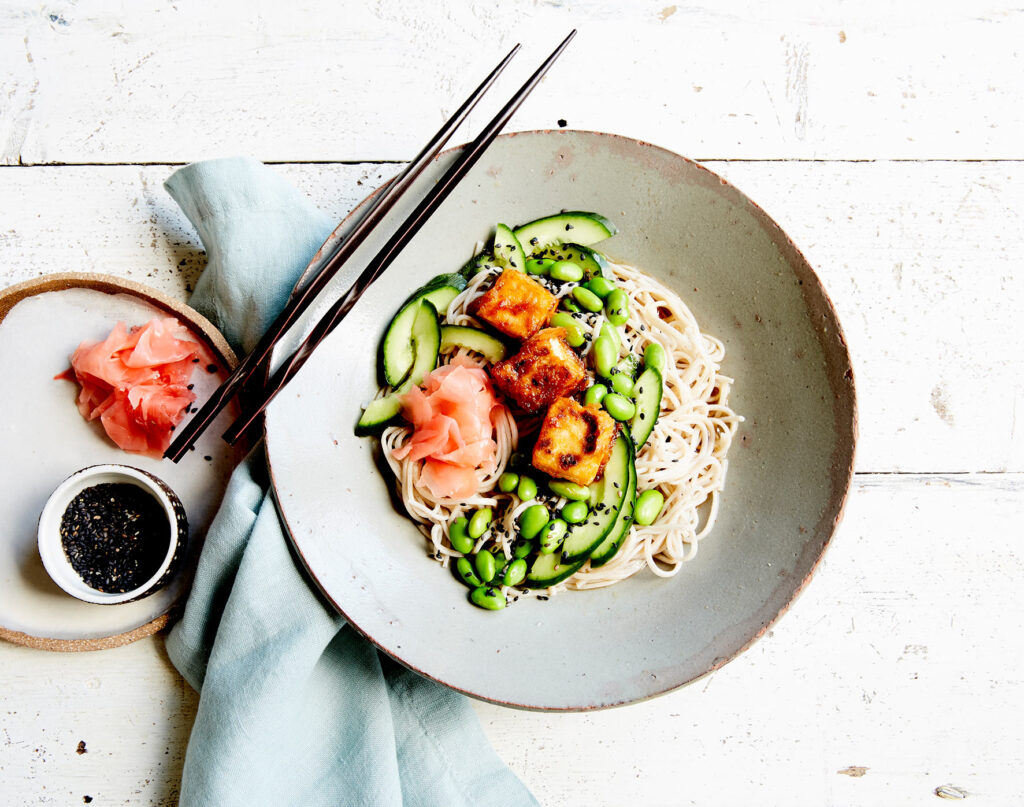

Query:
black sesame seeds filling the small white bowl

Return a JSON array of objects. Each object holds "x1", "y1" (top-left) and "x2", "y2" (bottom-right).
[{"x1": 60, "y1": 482, "x2": 171, "y2": 594}]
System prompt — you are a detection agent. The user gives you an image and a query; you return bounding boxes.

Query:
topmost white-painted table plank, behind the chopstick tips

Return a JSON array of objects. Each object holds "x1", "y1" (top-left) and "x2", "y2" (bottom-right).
[{"x1": 0, "y1": 0, "x2": 1024, "y2": 164}]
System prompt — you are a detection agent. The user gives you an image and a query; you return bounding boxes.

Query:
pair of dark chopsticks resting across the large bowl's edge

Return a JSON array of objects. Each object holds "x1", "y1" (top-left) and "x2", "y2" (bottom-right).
[{"x1": 164, "y1": 30, "x2": 577, "y2": 462}]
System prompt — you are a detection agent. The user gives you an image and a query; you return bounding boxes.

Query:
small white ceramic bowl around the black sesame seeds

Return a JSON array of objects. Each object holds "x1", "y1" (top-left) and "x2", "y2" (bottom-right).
[{"x1": 38, "y1": 465, "x2": 188, "y2": 605}]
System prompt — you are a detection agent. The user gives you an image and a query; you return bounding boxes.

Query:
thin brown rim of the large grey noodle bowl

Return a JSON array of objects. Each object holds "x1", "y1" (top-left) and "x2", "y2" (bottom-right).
[{"x1": 262, "y1": 128, "x2": 859, "y2": 714}]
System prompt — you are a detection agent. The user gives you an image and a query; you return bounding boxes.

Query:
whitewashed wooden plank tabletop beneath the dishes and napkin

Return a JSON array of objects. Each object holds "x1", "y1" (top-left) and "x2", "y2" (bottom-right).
[{"x1": 0, "y1": 0, "x2": 1024, "y2": 807}]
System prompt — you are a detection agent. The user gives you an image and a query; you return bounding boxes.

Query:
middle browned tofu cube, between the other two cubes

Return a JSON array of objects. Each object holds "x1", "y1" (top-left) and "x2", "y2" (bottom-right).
[{"x1": 490, "y1": 328, "x2": 587, "y2": 412}]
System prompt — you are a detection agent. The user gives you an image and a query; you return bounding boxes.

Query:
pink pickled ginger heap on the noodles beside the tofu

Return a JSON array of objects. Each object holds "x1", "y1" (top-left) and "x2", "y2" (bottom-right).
[{"x1": 392, "y1": 358, "x2": 502, "y2": 499}]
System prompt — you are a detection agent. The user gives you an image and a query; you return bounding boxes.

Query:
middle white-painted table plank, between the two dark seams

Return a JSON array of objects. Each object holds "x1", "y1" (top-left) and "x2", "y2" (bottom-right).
[{"x1": 0, "y1": 161, "x2": 1024, "y2": 472}]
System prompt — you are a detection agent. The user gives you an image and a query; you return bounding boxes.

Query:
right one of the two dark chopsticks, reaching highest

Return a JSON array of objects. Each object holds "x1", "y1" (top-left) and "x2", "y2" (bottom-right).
[{"x1": 224, "y1": 29, "x2": 577, "y2": 444}]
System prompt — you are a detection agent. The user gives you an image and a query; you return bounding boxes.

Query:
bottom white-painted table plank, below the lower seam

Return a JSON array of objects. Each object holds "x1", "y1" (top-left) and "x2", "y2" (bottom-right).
[{"x1": 0, "y1": 474, "x2": 1024, "y2": 807}]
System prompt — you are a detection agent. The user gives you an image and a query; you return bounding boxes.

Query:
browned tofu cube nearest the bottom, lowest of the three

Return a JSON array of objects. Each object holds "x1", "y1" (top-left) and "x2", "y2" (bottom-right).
[{"x1": 534, "y1": 398, "x2": 618, "y2": 484}]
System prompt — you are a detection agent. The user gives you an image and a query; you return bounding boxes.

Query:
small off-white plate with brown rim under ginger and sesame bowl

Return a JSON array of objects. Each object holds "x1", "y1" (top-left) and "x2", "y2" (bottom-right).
[{"x1": 0, "y1": 274, "x2": 240, "y2": 650}]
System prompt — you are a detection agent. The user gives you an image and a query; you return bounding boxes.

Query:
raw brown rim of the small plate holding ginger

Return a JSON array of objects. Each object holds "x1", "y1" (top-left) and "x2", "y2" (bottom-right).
[{"x1": 0, "y1": 271, "x2": 239, "y2": 652}]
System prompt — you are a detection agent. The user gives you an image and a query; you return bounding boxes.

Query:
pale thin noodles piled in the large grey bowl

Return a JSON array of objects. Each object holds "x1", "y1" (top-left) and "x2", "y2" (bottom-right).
[{"x1": 381, "y1": 263, "x2": 742, "y2": 598}]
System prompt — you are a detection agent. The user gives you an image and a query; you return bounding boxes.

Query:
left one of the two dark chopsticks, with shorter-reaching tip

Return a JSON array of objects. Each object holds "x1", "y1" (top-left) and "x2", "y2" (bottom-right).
[{"x1": 164, "y1": 44, "x2": 521, "y2": 462}]
